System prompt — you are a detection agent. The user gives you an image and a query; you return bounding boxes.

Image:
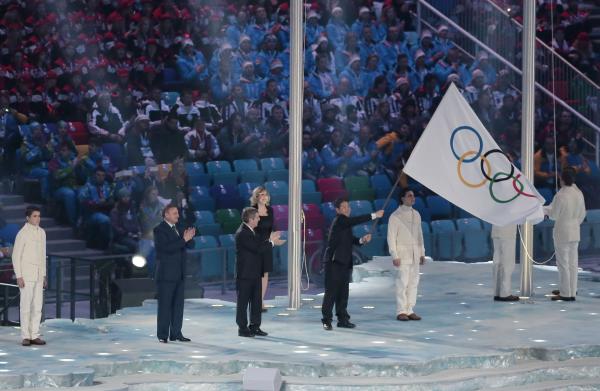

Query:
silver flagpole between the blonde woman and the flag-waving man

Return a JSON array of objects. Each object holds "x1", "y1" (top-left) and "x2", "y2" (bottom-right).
[{"x1": 288, "y1": 0, "x2": 304, "y2": 310}]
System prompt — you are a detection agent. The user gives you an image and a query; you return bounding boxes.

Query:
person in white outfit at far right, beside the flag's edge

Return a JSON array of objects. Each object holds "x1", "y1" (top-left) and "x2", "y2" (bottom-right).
[{"x1": 544, "y1": 167, "x2": 585, "y2": 301}]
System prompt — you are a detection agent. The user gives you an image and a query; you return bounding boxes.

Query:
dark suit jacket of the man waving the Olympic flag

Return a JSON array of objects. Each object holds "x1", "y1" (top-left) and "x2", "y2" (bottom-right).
[{"x1": 327, "y1": 214, "x2": 371, "y2": 267}]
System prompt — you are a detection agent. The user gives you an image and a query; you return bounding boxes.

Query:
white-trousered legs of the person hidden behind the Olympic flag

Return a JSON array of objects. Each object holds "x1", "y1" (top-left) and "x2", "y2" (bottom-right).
[{"x1": 492, "y1": 225, "x2": 519, "y2": 301}]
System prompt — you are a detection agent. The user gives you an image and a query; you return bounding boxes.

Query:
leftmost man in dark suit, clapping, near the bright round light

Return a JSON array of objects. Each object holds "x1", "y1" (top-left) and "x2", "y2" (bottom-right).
[{"x1": 154, "y1": 204, "x2": 196, "y2": 343}]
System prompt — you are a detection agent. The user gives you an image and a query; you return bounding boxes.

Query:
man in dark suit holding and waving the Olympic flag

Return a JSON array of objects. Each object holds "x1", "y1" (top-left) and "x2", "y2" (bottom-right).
[{"x1": 321, "y1": 197, "x2": 383, "y2": 330}]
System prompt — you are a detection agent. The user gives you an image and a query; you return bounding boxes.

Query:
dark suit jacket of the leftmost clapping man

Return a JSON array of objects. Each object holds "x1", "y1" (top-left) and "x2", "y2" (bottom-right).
[{"x1": 154, "y1": 220, "x2": 194, "y2": 282}]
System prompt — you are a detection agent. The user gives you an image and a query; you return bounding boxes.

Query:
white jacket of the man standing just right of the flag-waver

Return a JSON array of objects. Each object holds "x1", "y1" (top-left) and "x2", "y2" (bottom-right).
[{"x1": 387, "y1": 205, "x2": 425, "y2": 265}]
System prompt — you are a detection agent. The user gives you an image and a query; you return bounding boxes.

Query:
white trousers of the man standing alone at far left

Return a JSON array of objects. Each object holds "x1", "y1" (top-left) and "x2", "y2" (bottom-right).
[{"x1": 20, "y1": 281, "x2": 44, "y2": 339}]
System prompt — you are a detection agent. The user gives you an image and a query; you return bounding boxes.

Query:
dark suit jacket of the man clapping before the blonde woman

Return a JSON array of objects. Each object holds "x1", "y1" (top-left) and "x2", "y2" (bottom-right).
[{"x1": 235, "y1": 223, "x2": 272, "y2": 280}]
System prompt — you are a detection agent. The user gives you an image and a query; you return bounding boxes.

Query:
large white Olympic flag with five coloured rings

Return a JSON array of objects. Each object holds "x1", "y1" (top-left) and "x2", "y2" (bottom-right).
[{"x1": 404, "y1": 84, "x2": 544, "y2": 226}]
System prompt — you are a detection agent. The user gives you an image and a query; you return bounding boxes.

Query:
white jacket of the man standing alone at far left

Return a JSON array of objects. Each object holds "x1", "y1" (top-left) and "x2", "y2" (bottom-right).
[{"x1": 12, "y1": 223, "x2": 46, "y2": 281}]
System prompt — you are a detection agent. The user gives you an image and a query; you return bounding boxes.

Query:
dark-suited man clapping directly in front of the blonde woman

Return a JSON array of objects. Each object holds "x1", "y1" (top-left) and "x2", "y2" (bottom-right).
[{"x1": 235, "y1": 208, "x2": 283, "y2": 337}]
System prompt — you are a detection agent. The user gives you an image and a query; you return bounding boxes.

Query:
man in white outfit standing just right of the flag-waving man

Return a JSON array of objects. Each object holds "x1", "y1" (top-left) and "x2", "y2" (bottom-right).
[{"x1": 387, "y1": 189, "x2": 425, "y2": 321}]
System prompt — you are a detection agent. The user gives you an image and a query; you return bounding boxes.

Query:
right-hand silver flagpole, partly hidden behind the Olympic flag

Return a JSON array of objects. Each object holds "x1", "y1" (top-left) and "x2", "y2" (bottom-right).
[{"x1": 520, "y1": 1, "x2": 535, "y2": 297}]
